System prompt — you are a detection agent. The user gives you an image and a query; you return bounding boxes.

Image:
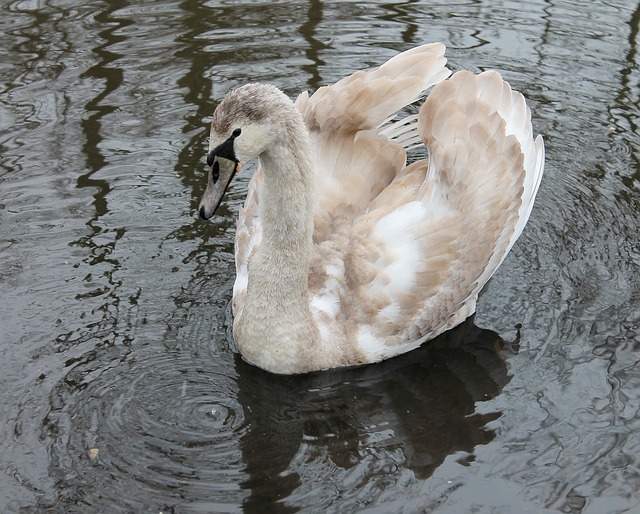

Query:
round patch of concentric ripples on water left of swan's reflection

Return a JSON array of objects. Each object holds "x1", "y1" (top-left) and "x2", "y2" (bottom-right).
[{"x1": 46, "y1": 351, "x2": 246, "y2": 512}]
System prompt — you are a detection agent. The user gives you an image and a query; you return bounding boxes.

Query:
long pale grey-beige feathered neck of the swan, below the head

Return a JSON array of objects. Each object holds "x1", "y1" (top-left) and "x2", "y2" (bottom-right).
[{"x1": 236, "y1": 109, "x2": 317, "y2": 373}]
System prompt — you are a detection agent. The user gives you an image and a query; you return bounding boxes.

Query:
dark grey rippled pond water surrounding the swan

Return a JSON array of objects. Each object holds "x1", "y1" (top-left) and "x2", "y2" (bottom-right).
[{"x1": 0, "y1": 0, "x2": 640, "y2": 513}]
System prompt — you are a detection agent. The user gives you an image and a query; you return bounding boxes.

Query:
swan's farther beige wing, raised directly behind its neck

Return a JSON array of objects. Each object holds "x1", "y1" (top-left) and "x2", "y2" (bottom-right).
[{"x1": 296, "y1": 43, "x2": 451, "y2": 227}]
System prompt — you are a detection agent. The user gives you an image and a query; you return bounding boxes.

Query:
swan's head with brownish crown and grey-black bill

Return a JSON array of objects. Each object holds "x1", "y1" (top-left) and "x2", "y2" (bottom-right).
[{"x1": 198, "y1": 84, "x2": 293, "y2": 220}]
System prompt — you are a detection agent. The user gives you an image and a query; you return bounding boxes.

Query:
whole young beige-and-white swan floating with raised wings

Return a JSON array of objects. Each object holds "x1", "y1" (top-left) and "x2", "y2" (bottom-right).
[{"x1": 198, "y1": 43, "x2": 544, "y2": 374}]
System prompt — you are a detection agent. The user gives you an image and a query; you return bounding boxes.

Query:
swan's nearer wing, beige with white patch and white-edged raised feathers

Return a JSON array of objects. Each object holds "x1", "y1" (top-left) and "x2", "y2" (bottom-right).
[{"x1": 311, "y1": 72, "x2": 544, "y2": 362}]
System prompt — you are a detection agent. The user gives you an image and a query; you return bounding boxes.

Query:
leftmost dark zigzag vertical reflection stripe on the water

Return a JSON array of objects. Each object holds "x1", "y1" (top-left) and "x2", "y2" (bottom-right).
[{"x1": 56, "y1": 0, "x2": 140, "y2": 356}]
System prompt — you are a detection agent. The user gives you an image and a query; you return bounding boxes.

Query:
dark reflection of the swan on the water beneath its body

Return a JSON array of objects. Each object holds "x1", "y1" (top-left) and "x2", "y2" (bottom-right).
[{"x1": 236, "y1": 318, "x2": 508, "y2": 512}]
